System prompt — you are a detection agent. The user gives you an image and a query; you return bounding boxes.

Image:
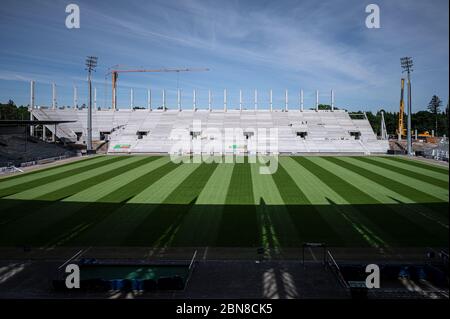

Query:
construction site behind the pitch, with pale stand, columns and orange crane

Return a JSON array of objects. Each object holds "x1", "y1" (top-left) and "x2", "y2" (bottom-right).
[{"x1": 3, "y1": 61, "x2": 448, "y2": 170}]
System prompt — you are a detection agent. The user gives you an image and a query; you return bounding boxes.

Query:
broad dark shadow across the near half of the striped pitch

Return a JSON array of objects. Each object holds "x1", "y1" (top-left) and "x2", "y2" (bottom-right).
[{"x1": 0, "y1": 199, "x2": 449, "y2": 248}]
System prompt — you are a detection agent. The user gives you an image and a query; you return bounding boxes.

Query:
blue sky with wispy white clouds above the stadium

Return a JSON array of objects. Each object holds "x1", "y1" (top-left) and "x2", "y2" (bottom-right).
[{"x1": 0, "y1": 0, "x2": 449, "y2": 111}]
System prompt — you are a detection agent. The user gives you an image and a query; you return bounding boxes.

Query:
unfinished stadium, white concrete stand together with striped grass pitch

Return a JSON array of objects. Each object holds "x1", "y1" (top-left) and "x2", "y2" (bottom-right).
[{"x1": 0, "y1": 82, "x2": 448, "y2": 298}]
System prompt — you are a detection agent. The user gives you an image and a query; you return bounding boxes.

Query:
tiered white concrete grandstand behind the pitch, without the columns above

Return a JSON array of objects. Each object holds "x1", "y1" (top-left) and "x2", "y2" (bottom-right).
[{"x1": 32, "y1": 108, "x2": 389, "y2": 154}]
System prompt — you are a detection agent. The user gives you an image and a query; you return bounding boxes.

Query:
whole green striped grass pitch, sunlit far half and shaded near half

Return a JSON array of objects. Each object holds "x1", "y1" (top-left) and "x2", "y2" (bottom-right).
[{"x1": 0, "y1": 156, "x2": 449, "y2": 248}]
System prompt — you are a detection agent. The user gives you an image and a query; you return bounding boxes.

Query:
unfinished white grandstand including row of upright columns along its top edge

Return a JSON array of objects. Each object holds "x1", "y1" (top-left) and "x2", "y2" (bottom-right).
[{"x1": 30, "y1": 80, "x2": 389, "y2": 154}]
